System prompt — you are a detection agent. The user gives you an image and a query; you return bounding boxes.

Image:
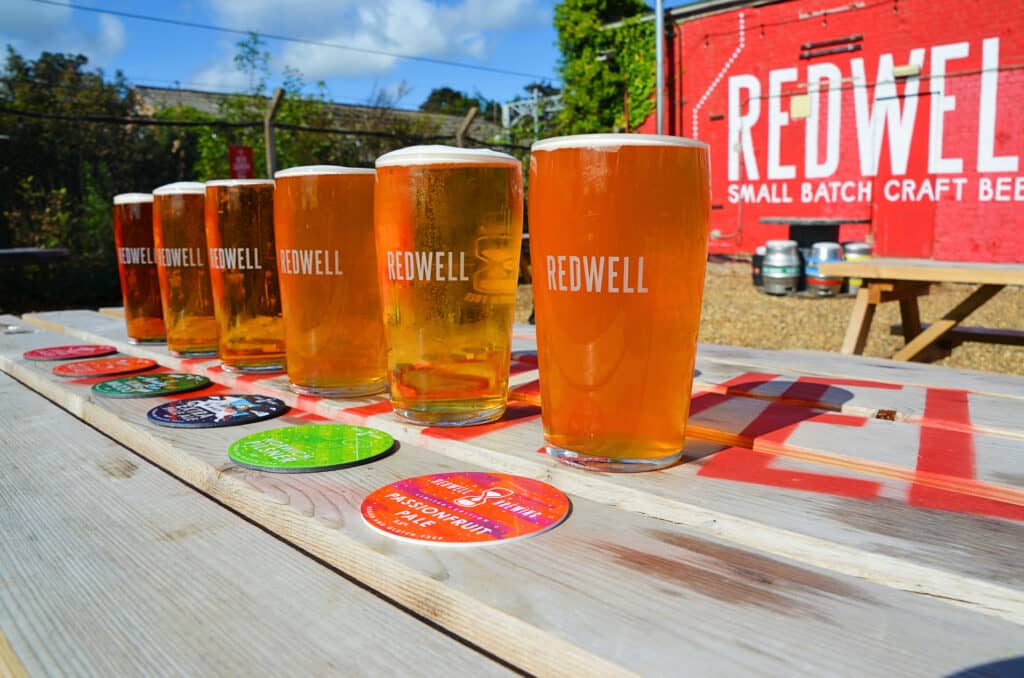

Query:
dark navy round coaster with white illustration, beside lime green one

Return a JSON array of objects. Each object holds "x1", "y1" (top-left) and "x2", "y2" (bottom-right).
[{"x1": 146, "y1": 393, "x2": 288, "y2": 428}]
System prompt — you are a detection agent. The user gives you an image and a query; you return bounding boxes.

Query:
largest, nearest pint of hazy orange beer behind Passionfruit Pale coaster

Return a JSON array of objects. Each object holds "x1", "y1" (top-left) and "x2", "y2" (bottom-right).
[{"x1": 529, "y1": 134, "x2": 710, "y2": 471}]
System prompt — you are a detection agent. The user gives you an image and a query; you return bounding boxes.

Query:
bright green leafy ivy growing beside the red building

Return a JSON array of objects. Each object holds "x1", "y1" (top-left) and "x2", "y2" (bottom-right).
[{"x1": 554, "y1": 0, "x2": 654, "y2": 134}]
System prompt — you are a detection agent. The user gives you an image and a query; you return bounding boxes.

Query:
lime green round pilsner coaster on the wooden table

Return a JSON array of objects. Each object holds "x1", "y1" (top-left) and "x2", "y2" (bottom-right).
[{"x1": 227, "y1": 424, "x2": 394, "y2": 473}]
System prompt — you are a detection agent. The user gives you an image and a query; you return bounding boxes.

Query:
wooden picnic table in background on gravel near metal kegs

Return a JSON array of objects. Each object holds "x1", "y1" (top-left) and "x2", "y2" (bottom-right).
[{"x1": 819, "y1": 257, "x2": 1024, "y2": 361}]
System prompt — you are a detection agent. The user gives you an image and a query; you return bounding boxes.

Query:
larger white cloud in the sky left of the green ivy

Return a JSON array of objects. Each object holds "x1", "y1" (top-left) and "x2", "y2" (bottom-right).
[{"x1": 197, "y1": 0, "x2": 548, "y2": 81}]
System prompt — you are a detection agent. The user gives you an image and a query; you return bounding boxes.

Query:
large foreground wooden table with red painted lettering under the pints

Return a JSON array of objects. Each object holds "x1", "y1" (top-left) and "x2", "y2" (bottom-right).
[{"x1": 0, "y1": 311, "x2": 1024, "y2": 676}]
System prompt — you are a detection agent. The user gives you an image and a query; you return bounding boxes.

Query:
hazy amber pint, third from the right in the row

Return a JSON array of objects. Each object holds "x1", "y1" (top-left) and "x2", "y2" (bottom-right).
[{"x1": 273, "y1": 165, "x2": 387, "y2": 396}]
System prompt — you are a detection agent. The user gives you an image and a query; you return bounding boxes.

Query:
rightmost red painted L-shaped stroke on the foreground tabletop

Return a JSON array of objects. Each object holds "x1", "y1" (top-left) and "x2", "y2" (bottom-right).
[{"x1": 907, "y1": 388, "x2": 1024, "y2": 520}]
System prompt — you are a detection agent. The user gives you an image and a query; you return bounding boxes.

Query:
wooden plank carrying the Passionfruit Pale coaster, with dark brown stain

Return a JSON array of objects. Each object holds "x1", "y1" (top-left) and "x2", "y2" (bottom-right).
[{"x1": 3, "y1": 348, "x2": 1024, "y2": 675}]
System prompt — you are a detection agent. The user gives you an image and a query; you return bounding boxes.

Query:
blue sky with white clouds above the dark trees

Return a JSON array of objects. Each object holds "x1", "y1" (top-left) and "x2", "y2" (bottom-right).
[{"x1": 0, "y1": 0, "x2": 558, "y2": 109}]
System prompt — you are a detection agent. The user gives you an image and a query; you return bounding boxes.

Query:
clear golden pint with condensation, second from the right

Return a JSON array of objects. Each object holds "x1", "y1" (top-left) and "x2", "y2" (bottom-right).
[{"x1": 374, "y1": 146, "x2": 522, "y2": 426}]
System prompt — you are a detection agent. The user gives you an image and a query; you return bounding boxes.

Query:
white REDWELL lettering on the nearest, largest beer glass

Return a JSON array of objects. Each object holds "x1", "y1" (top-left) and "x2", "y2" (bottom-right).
[{"x1": 547, "y1": 255, "x2": 647, "y2": 294}]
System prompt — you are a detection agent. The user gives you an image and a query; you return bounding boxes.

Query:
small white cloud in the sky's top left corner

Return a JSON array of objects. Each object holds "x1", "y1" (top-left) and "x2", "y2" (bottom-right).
[{"x1": 0, "y1": 2, "x2": 125, "y2": 67}]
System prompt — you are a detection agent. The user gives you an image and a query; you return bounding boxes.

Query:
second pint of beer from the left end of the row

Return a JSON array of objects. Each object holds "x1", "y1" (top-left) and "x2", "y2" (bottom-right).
[{"x1": 153, "y1": 181, "x2": 217, "y2": 357}]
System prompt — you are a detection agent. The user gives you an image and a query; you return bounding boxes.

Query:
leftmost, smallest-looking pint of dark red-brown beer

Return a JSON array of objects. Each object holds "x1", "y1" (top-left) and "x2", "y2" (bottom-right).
[{"x1": 114, "y1": 193, "x2": 164, "y2": 344}]
